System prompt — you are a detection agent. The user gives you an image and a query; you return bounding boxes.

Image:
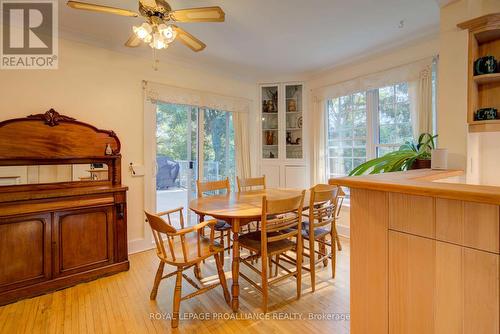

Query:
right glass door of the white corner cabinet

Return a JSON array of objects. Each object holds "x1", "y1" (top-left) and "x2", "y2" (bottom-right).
[{"x1": 285, "y1": 85, "x2": 304, "y2": 159}]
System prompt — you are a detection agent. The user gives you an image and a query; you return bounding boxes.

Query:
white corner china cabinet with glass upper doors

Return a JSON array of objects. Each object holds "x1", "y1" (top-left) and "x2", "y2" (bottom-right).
[{"x1": 260, "y1": 82, "x2": 308, "y2": 188}]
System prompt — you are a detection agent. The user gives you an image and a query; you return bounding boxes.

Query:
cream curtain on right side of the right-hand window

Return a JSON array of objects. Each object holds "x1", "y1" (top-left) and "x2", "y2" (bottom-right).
[{"x1": 409, "y1": 63, "x2": 433, "y2": 138}]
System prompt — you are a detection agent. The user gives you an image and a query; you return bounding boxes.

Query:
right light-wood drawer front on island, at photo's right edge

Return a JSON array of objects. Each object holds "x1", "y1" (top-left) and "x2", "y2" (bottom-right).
[{"x1": 436, "y1": 198, "x2": 500, "y2": 253}]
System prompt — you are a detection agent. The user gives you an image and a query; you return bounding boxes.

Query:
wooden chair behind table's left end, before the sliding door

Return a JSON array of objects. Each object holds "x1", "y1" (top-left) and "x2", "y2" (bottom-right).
[{"x1": 196, "y1": 178, "x2": 231, "y2": 265}]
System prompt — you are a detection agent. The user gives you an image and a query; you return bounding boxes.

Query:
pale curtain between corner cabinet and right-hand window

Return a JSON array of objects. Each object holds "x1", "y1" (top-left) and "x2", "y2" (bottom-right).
[{"x1": 311, "y1": 98, "x2": 328, "y2": 184}]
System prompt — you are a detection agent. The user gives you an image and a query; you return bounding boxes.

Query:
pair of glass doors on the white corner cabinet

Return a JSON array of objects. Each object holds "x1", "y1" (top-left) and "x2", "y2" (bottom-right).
[{"x1": 261, "y1": 83, "x2": 304, "y2": 161}]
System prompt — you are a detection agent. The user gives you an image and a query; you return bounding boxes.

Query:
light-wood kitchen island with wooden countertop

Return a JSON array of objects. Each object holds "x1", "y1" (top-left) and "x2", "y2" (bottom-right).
[{"x1": 329, "y1": 169, "x2": 500, "y2": 334}]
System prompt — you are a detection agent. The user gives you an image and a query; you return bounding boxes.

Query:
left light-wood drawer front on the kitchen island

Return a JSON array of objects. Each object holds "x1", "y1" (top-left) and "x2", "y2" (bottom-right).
[{"x1": 389, "y1": 193, "x2": 435, "y2": 238}]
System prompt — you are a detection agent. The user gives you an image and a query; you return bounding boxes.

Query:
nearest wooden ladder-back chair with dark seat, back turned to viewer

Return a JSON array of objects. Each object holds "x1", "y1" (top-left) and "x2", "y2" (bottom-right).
[{"x1": 239, "y1": 190, "x2": 305, "y2": 313}]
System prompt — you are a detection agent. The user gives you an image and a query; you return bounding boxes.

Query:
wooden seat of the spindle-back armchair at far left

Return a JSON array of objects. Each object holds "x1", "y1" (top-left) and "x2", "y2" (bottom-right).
[{"x1": 162, "y1": 233, "x2": 224, "y2": 266}]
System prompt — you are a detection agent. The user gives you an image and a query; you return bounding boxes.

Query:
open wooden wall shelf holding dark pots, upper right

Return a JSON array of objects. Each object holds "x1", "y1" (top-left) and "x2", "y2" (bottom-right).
[{"x1": 458, "y1": 13, "x2": 500, "y2": 132}]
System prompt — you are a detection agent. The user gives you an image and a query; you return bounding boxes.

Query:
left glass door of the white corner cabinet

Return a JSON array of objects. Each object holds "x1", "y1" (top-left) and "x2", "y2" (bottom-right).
[{"x1": 261, "y1": 86, "x2": 279, "y2": 159}]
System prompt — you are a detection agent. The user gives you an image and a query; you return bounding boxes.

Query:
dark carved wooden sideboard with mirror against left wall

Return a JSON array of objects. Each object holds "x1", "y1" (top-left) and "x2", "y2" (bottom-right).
[{"x1": 0, "y1": 110, "x2": 129, "y2": 305}]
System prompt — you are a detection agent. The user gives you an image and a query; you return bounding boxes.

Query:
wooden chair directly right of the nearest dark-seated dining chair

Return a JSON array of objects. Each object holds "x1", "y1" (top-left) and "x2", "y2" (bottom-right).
[{"x1": 302, "y1": 184, "x2": 340, "y2": 292}]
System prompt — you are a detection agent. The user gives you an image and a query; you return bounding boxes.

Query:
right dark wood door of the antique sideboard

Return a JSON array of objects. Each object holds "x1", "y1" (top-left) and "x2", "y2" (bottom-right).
[{"x1": 53, "y1": 206, "x2": 114, "y2": 276}]
